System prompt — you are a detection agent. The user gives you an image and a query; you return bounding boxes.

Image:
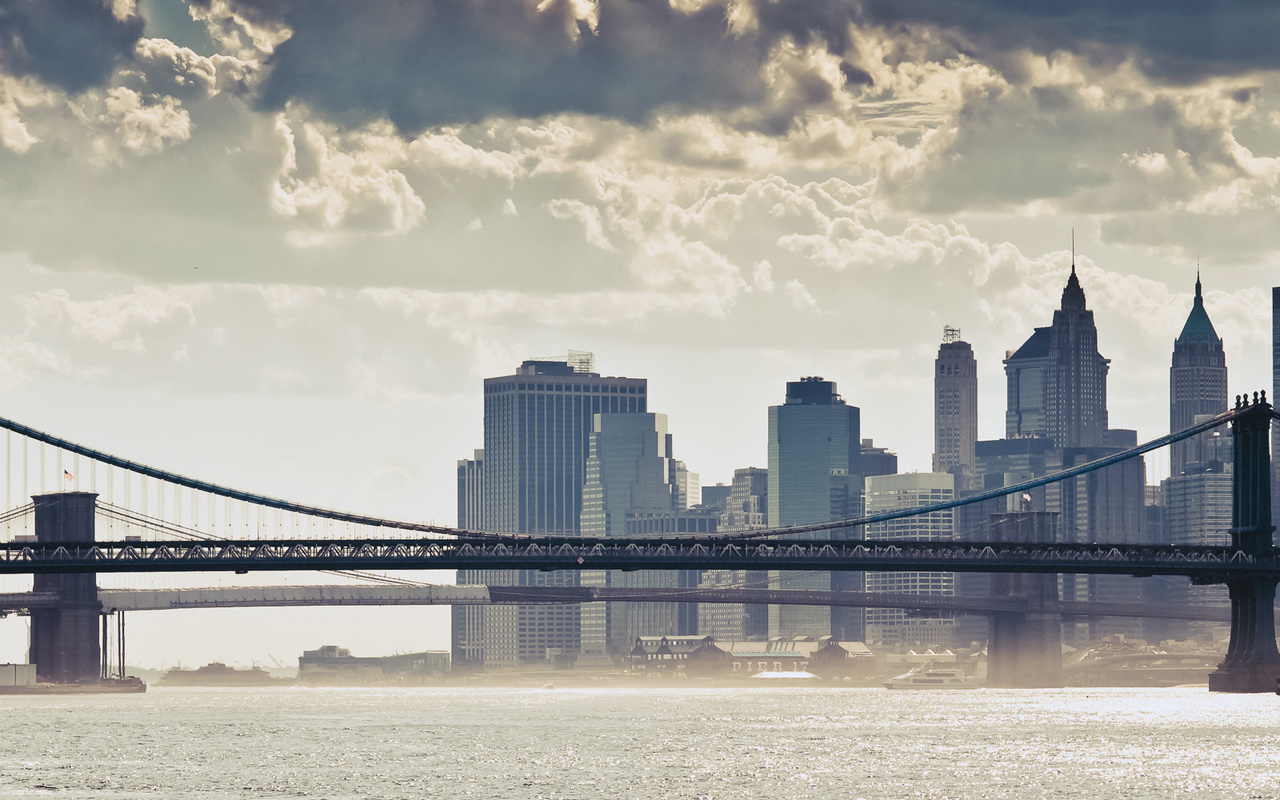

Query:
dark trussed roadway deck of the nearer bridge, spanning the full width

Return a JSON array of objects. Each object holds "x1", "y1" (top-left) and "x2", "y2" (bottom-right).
[{"x1": 0, "y1": 536, "x2": 1280, "y2": 584}]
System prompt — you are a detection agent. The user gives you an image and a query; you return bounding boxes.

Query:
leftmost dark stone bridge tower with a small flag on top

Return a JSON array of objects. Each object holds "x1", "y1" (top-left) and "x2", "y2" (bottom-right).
[{"x1": 31, "y1": 492, "x2": 102, "y2": 684}]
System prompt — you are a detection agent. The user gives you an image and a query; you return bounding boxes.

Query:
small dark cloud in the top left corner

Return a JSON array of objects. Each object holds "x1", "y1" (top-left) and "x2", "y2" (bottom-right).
[{"x1": 0, "y1": 0, "x2": 142, "y2": 92}]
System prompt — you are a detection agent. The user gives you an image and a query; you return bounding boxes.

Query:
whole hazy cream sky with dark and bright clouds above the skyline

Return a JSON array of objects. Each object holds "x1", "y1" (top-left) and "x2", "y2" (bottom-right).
[{"x1": 0, "y1": 0, "x2": 1280, "y2": 664}]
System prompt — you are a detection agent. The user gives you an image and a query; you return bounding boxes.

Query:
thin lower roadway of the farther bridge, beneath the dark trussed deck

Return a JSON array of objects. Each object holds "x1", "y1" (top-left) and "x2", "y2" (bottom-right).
[{"x1": 0, "y1": 585, "x2": 1228, "y2": 622}]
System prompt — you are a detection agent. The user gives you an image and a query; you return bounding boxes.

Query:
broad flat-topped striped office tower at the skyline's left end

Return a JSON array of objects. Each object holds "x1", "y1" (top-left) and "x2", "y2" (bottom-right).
[{"x1": 453, "y1": 351, "x2": 648, "y2": 669}]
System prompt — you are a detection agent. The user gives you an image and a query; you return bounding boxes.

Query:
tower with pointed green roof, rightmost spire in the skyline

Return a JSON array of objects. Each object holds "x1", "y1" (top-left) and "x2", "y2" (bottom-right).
[{"x1": 1169, "y1": 274, "x2": 1228, "y2": 477}]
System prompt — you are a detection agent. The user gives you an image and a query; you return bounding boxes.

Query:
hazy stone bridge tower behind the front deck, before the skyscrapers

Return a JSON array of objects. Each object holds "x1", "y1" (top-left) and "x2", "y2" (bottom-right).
[{"x1": 987, "y1": 511, "x2": 1062, "y2": 689}]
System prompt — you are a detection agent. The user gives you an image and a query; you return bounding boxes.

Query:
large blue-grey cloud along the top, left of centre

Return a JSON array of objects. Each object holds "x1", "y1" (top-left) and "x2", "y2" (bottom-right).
[{"x1": 196, "y1": 0, "x2": 869, "y2": 131}]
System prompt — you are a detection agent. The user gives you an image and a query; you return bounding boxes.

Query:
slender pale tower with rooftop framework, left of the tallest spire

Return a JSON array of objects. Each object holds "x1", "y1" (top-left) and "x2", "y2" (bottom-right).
[{"x1": 933, "y1": 326, "x2": 978, "y2": 489}]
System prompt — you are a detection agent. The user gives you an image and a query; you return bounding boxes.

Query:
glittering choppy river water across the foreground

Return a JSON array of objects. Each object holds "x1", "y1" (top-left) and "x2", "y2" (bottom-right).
[{"x1": 0, "y1": 687, "x2": 1280, "y2": 800}]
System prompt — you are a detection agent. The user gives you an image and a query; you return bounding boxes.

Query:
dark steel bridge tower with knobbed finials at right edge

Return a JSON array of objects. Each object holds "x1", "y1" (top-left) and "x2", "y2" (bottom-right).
[{"x1": 1208, "y1": 392, "x2": 1280, "y2": 692}]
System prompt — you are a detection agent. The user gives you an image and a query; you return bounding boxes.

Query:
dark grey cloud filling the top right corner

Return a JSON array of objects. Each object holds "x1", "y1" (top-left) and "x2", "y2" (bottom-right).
[{"x1": 860, "y1": 0, "x2": 1280, "y2": 83}]
